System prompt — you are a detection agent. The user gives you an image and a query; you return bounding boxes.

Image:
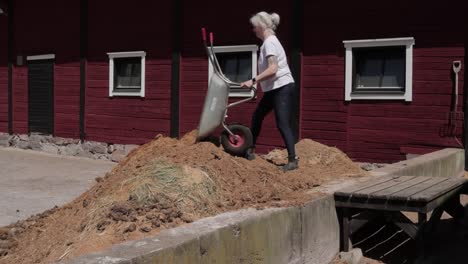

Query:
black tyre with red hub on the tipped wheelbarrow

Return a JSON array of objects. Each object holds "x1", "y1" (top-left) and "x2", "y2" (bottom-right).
[{"x1": 221, "y1": 124, "x2": 253, "y2": 156}]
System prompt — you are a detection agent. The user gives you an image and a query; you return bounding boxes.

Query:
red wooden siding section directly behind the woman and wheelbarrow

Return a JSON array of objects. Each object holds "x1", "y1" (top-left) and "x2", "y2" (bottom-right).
[{"x1": 179, "y1": 1, "x2": 292, "y2": 152}]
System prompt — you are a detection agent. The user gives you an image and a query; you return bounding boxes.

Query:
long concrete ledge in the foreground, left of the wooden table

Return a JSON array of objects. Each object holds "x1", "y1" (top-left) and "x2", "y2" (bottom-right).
[{"x1": 64, "y1": 195, "x2": 339, "y2": 264}]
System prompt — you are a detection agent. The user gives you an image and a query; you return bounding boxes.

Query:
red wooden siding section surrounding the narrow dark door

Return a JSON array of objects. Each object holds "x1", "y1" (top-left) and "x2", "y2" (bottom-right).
[{"x1": 13, "y1": 0, "x2": 80, "y2": 137}]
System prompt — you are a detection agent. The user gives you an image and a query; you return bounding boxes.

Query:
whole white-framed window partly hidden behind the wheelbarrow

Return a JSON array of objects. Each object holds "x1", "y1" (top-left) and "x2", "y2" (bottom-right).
[{"x1": 208, "y1": 45, "x2": 258, "y2": 97}]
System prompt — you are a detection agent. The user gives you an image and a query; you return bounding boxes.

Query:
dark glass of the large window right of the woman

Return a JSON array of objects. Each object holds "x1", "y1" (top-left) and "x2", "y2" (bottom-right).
[{"x1": 353, "y1": 47, "x2": 405, "y2": 90}]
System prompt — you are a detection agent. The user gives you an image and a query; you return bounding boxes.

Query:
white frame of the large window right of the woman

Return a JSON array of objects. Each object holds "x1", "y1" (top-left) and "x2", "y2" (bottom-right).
[{"x1": 343, "y1": 37, "x2": 414, "y2": 102}]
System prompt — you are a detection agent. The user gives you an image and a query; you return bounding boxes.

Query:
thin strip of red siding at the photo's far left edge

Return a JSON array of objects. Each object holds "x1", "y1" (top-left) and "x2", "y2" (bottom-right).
[{"x1": 0, "y1": 15, "x2": 8, "y2": 132}]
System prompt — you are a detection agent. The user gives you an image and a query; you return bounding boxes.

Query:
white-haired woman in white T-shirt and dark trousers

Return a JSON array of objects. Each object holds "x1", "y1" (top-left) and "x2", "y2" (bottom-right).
[{"x1": 241, "y1": 12, "x2": 298, "y2": 171}]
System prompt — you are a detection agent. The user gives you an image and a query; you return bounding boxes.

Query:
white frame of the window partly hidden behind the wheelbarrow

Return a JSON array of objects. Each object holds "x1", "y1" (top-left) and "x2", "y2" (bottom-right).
[{"x1": 208, "y1": 45, "x2": 258, "y2": 97}]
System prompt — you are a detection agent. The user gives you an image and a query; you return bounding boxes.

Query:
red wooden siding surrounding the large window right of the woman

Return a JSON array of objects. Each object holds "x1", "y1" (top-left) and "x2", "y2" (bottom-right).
[{"x1": 301, "y1": 1, "x2": 465, "y2": 162}]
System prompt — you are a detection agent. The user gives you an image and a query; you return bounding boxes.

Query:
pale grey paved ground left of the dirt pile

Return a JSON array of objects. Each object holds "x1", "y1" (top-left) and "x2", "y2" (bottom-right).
[{"x1": 0, "y1": 148, "x2": 116, "y2": 226}]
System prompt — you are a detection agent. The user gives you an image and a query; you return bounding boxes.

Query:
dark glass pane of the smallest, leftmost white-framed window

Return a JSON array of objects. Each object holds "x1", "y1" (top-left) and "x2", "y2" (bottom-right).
[{"x1": 114, "y1": 57, "x2": 141, "y2": 89}]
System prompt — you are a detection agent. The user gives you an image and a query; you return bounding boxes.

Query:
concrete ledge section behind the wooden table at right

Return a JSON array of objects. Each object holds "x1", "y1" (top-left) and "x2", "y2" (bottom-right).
[{"x1": 371, "y1": 148, "x2": 465, "y2": 177}]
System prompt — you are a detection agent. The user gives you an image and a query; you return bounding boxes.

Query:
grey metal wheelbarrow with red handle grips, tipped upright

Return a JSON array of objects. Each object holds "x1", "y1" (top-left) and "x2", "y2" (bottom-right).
[{"x1": 197, "y1": 28, "x2": 257, "y2": 156}]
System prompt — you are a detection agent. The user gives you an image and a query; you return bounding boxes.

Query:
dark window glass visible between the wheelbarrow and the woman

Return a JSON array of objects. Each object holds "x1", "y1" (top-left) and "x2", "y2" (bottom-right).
[{"x1": 216, "y1": 52, "x2": 252, "y2": 82}]
